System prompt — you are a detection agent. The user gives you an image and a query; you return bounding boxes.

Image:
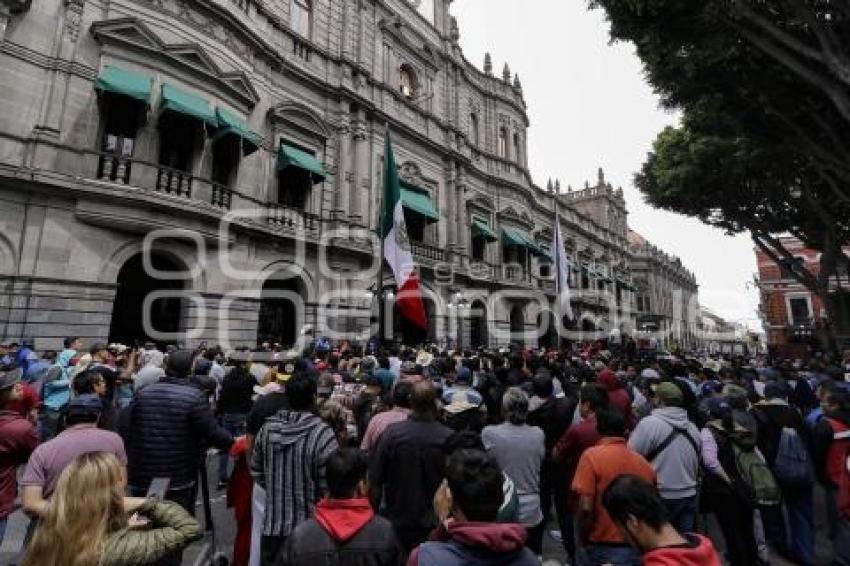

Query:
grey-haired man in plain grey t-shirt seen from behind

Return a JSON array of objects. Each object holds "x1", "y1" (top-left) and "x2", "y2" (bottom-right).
[{"x1": 481, "y1": 387, "x2": 546, "y2": 556}]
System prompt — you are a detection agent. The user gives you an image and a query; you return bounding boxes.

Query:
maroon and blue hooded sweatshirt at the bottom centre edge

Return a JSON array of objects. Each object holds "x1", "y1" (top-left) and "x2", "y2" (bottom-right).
[{"x1": 407, "y1": 523, "x2": 539, "y2": 566}]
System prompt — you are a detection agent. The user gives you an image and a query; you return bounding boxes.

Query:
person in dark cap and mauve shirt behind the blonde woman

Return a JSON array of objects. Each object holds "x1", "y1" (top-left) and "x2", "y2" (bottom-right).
[{"x1": 21, "y1": 393, "x2": 127, "y2": 517}]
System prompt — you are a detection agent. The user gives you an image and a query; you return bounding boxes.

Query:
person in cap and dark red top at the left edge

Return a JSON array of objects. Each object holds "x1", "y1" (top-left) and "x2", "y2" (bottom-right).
[{"x1": 0, "y1": 369, "x2": 38, "y2": 545}]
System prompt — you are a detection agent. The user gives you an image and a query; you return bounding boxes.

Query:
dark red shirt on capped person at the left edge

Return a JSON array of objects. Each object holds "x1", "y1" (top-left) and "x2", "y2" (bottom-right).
[{"x1": 0, "y1": 411, "x2": 38, "y2": 519}]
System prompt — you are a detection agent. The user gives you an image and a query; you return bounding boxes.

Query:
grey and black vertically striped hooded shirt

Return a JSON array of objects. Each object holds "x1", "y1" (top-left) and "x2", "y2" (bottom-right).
[{"x1": 251, "y1": 409, "x2": 339, "y2": 537}]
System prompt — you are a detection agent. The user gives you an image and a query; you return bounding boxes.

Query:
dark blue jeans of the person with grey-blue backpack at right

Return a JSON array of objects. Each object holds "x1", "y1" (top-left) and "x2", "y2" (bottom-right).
[{"x1": 762, "y1": 486, "x2": 815, "y2": 564}]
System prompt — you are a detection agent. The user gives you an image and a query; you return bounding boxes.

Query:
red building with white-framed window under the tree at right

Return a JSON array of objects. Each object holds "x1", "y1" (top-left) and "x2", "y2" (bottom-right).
[{"x1": 755, "y1": 237, "x2": 850, "y2": 358}]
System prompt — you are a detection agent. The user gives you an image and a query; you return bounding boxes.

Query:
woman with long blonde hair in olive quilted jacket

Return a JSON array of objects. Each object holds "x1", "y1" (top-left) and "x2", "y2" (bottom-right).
[{"x1": 23, "y1": 452, "x2": 201, "y2": 566}]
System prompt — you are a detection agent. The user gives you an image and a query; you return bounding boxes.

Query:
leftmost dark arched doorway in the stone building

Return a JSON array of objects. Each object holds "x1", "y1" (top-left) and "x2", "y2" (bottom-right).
[{"x1": 109, "y1": 252, "x2": 184, "y2": 345}]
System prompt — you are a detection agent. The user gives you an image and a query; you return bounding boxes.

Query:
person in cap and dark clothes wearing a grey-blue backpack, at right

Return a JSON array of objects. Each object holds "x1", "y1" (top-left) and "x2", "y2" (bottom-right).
[{"x1": 750, "y1": 381, "x2": 815, "y2": 564}]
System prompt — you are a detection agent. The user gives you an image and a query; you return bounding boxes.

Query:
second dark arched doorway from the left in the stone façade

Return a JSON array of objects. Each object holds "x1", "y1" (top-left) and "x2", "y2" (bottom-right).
[{"x1": 257, "y1": 276, "x2": 307, "y2": 348}]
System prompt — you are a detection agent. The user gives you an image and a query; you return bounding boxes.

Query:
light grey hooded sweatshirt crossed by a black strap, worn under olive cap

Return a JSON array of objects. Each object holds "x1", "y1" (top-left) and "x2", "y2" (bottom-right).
[{"x1": 629, "y1": 407, "x2": 702, "y2": 499}]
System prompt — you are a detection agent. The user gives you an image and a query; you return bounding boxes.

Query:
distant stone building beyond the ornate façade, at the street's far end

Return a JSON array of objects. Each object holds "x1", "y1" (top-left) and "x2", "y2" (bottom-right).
[{"x1": 629, "y1": 230, "x2": 701, "y2": 349}]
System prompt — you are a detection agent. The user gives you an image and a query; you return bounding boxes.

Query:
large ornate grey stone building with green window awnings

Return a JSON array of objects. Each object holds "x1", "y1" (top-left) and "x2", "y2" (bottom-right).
[{"x1": 0, "y1": 0, "x2": 684, "y2": 348}]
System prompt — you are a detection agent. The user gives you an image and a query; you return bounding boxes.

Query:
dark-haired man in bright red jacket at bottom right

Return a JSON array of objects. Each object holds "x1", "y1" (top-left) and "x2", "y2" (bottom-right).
[{"x1": 602, "y1": 475, "x2": 721, "y2": 566}]
